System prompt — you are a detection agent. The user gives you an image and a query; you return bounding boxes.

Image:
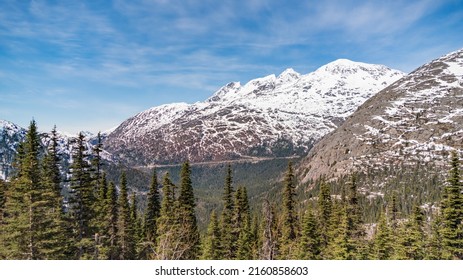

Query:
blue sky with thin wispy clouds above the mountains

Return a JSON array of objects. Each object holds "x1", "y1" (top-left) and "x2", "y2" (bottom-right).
[{"x1": 0, "y1": 0, "x2": 463, "y2": 133}]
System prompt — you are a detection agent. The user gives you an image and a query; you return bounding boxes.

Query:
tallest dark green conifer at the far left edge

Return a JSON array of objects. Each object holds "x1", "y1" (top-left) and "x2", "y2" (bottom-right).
[{"x1": 0, "y1": 121, "x2": 44, "y2": 259}]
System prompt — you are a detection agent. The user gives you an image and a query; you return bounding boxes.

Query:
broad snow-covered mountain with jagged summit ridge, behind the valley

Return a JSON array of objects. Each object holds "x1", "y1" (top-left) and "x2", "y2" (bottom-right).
[{"x1": 104, "y1": 59, "x2": 404, "y2": 165}]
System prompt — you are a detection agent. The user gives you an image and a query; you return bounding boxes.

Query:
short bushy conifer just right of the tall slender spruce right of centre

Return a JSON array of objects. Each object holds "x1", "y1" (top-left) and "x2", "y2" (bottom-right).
[{"x1": 299, "y1": 207, "x2": 321, "y2": 260}]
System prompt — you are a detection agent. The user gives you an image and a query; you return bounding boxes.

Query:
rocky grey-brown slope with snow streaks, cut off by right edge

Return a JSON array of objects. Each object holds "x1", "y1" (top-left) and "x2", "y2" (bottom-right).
[{"x1": 300, "y1": 49, "x2": 463, "y2": 181}]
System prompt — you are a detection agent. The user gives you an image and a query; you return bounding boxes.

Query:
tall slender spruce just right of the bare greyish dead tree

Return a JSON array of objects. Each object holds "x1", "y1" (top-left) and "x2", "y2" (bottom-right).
[{"x1": 281, "y1": 162, "x2": 297, "y2": 258}]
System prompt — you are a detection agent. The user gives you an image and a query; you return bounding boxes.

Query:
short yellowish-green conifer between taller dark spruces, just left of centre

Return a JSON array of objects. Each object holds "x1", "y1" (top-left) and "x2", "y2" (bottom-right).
[{"x1": 202, "y1": 211, "x2": 222, "y2": 260}]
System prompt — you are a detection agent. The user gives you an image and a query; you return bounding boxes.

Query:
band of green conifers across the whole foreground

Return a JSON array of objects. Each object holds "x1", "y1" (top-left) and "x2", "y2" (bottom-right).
[{"x1": 0, "y1": 121, "x2": 463, "y2": 260}]
